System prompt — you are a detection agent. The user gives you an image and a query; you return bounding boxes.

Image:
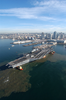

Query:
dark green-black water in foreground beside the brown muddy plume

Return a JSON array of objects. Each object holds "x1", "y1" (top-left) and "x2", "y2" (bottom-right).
[{"x1": 0, "y1": 61, "x2": 66, "y2": 100}]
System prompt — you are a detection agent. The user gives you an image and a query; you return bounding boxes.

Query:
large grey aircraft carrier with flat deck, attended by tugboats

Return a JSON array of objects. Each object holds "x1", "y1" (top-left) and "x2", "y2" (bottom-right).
[{"x1": 7, "y1": 44, "x2": 53, "y2": 68}]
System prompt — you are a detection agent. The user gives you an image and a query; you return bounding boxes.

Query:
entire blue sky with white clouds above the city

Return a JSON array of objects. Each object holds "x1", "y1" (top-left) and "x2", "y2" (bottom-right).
[{"x1": 0, "y1": 0, "x2": 66, "y2": 33}]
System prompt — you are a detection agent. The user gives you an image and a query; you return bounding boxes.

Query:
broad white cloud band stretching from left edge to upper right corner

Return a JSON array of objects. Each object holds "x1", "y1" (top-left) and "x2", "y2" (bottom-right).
[{"x1": 0, "y1": 0, "x2": 66, "y2": 21}]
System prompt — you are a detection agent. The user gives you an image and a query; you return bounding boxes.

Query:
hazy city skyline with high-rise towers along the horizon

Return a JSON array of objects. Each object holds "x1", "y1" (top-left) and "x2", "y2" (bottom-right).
[{"x1": 0, "y1": 31, "x2": 66, "y2": 40}]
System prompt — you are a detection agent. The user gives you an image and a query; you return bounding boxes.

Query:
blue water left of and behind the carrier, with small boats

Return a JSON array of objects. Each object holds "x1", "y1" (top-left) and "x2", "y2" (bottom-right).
[{"x1": 0, "y1": 39, "x2": 32, "y2": 63}]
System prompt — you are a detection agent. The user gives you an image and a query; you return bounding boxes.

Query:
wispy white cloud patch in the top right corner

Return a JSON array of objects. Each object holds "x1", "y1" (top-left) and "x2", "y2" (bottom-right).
[{"x1": 34, "y1": 0, "x2": 66, "y2": 12}]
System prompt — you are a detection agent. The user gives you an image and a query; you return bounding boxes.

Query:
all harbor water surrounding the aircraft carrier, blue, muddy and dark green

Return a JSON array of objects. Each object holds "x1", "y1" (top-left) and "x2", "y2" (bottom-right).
[{"x1": 0, "y1": 39, "x2": 66, "y2": 100}]
